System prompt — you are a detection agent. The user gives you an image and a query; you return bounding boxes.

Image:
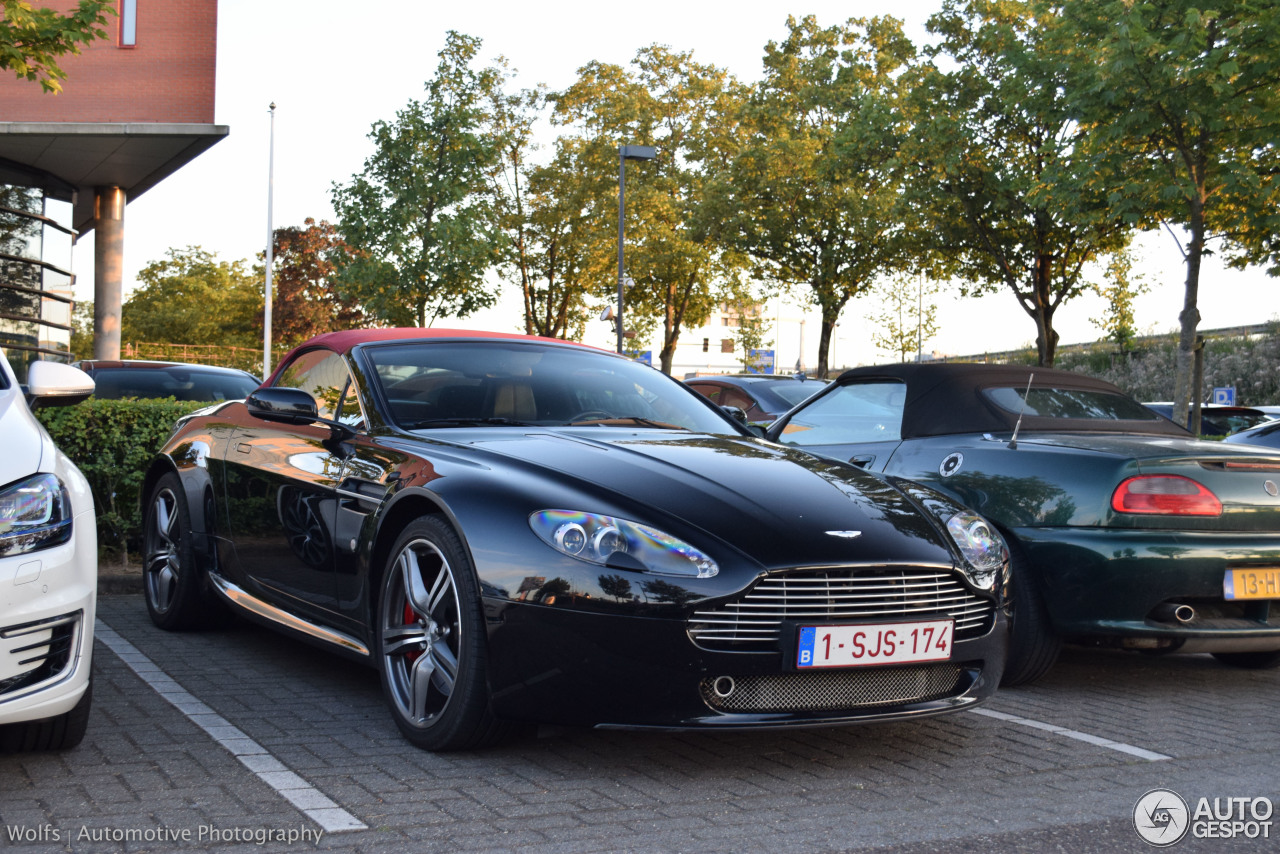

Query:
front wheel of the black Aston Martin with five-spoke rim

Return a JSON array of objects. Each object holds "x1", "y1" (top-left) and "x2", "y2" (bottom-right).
[{"x1": 375, "y1": 516, "x2": 511, "y2": 750}]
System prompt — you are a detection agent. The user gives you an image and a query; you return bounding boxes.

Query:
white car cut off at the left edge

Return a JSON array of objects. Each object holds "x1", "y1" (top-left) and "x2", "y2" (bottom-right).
[{"x1": 0, "y1": 352, "x2": 97, "y2": 752}]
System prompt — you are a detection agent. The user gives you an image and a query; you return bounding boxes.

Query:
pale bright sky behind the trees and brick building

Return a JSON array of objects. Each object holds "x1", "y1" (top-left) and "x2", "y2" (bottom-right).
[{"x1": 76, "y1": 0, "x2": 1277, "y2": 365}]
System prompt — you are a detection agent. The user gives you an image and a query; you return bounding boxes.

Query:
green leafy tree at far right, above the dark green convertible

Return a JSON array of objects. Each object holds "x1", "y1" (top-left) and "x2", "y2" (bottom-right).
[{"x1": 1053, "y1": 0, "x2": 1280, "y2": 425}]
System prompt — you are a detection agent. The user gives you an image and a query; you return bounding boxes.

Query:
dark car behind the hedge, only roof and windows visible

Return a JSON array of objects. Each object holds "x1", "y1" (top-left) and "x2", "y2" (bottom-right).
[{"x1": 76, "y1": 360, "x2": 260, "y2": 402}]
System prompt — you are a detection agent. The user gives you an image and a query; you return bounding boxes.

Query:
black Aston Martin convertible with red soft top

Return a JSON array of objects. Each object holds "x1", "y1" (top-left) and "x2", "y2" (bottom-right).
[{"x1": 143, "y1": 329, "x2": 1007, "y2": 749}]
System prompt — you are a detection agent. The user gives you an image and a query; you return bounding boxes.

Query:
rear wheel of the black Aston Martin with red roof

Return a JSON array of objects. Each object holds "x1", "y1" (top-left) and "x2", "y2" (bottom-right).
[{"x1": 142, "y1": 472, "x2": 221, "y2": 631}]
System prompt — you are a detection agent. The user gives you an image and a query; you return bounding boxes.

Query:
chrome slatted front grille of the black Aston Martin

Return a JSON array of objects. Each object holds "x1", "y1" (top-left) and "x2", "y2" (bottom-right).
[{"x1": 689, "y1": 566, "x2": 995, "y2": 652}]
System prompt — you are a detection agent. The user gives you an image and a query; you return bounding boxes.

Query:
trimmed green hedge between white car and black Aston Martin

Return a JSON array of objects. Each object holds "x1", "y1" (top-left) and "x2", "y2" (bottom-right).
[{"x1": 36, "y1": 397, "x2": 207, "y2": 560}]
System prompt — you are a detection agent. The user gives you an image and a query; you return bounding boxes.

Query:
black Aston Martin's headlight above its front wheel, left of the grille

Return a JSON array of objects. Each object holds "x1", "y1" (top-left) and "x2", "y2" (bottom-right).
[{"x1": 529, "y1": 510, "x2": 719, "y2": 579}]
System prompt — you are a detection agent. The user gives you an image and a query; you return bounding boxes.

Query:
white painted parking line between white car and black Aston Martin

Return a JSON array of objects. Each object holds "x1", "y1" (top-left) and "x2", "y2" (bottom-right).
[{"x1": 93, "y1": 617, "x2": 369, "y2": 834}]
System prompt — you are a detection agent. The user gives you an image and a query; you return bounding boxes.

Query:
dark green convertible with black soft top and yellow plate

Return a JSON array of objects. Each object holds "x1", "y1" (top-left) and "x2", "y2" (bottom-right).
[{"x1": 768, "y1": 364, "x2": 1280, "y2": 684}]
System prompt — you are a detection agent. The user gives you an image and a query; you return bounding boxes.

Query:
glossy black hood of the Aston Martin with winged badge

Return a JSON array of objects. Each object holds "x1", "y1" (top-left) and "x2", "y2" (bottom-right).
[{"x1": 455, "y1": 428, "x2": 952, "y2": 567}]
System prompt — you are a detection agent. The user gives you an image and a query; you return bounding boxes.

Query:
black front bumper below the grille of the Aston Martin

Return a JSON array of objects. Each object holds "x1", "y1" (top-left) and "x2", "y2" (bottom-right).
[{"x1": 485, "y1": 599, "x2": 1007, "y2": 730}]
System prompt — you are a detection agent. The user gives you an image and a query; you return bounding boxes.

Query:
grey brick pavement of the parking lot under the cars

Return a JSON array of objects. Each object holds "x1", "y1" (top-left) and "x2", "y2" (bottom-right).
[{"x1": 0, "y1": 595, "x2": 1280, "y2": 854}]
